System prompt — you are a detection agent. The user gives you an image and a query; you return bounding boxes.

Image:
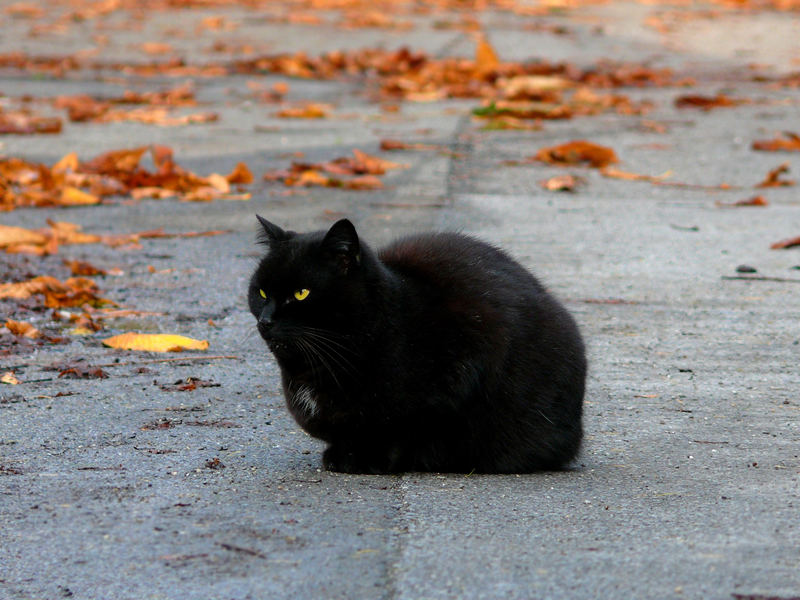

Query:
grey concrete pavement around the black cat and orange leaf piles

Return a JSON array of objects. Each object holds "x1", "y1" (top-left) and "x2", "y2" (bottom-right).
[{"x1": 0, "y1": 4, "x2": 800, "y2": 600}]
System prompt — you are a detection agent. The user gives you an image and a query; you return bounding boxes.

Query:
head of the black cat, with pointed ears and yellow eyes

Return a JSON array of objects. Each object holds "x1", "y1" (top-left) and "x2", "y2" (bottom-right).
[{"x1": 248, "y1": 216, "x2": 370, "y2": 360}]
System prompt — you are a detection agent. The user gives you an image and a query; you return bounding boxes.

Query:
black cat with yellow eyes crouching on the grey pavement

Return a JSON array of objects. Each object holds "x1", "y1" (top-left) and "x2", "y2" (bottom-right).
[{"x1": 249, "y1": 217, "x2": 586, "y2": 473}]
